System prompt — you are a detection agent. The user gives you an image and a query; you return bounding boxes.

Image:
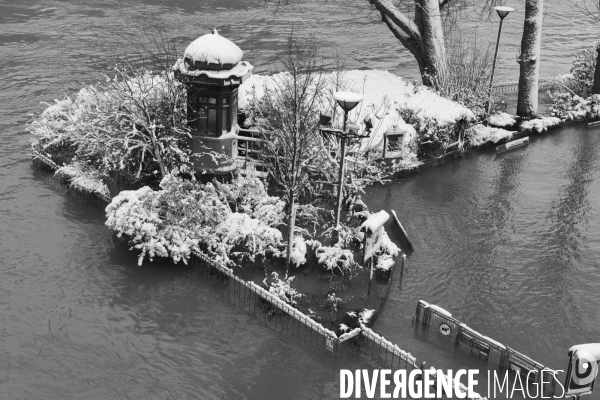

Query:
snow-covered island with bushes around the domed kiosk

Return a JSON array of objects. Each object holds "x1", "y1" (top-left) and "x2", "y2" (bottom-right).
[{"x1": 29, "y1": 31, "x2": 600, "y2": 335}]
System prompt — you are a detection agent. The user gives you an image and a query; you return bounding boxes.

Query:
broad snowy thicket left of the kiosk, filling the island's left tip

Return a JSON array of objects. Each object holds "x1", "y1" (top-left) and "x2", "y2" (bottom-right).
[{"x1": 28, "y1": 65, "x2": 190, "y2": 186}]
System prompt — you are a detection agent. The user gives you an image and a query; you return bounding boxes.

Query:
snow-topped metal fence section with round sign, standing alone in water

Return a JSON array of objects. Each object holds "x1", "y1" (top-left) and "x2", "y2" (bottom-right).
[{"x1": 415, "y1": 300, "x2": 556, "y2": 396}]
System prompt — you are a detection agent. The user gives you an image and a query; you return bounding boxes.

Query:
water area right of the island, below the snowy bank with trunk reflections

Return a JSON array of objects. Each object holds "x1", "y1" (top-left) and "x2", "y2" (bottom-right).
[{"x1": 370, "y1": 126, "x2": 600, "y2": 398}]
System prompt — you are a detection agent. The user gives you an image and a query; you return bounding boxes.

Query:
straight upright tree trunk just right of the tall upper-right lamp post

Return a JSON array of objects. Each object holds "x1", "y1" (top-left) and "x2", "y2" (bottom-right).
[{"x1": 517, "y1": 0, "x2": 544, "y2": 118}]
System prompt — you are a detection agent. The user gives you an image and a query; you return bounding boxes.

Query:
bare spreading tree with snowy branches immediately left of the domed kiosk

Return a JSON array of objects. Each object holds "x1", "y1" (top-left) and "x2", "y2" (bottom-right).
[{"x1": 92, "y1": 63, "x2": 190, "y2": 179}]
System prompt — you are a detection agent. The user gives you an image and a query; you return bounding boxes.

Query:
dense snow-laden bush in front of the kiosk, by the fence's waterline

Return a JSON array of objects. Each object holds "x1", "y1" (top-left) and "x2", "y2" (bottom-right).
[{"x1": 106, "y1": 174, "x2": 283, "y2": 266}]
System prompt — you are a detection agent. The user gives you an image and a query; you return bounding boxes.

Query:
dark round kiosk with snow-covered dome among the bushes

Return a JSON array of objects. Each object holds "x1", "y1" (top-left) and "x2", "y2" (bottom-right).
[{"x1": 173, "y1": 29, "x2": 253, "y2": 175}]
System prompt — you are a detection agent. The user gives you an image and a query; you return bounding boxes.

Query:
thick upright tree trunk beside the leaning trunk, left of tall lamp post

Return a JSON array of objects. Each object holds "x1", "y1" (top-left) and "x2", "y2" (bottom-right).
[{"x1": 416, "y1": 0, "x2": 446, "y2": 86}]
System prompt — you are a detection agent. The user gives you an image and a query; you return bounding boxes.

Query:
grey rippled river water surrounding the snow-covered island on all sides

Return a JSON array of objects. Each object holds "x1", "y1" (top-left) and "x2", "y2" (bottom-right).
[{"x1": 0, "y1": 0, "x2": 600, "y2": 399}]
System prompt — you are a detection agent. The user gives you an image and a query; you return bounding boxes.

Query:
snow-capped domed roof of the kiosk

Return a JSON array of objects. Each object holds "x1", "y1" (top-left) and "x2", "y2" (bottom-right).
[{"x1": 183, "y1": 29, "x2": 244, "y2": 69}]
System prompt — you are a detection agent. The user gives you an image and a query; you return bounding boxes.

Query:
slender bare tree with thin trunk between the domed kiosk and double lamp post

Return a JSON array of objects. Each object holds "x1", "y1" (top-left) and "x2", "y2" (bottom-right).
[{"x1": 250, "y1": 34, "x2": 325, "y2": 276}]
